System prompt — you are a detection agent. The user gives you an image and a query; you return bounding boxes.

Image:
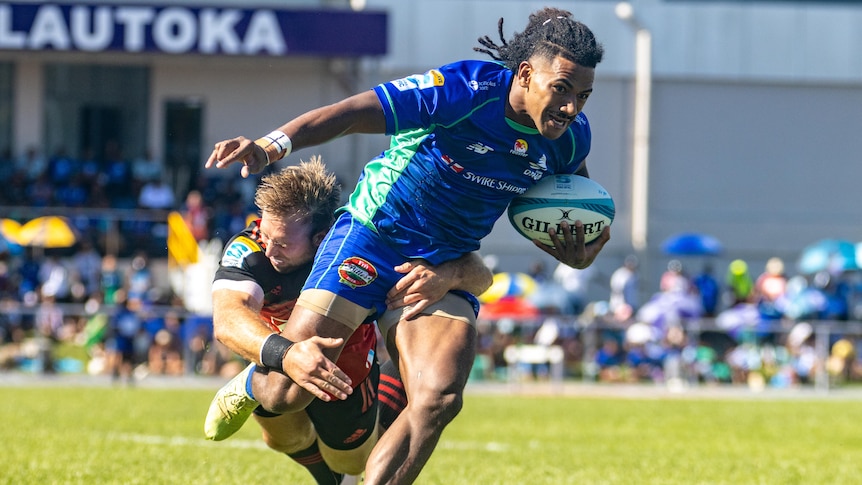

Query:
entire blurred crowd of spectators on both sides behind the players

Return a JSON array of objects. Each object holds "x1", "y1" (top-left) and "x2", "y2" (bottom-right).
[{"x1": 0, "y1": 143, "x2": 862, "y2": 386}]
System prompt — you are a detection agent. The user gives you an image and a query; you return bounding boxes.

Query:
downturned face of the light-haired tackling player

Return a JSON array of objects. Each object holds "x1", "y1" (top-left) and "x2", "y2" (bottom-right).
[{"x1": 260, "y1": 211, "x2": 317, "y2": 273}]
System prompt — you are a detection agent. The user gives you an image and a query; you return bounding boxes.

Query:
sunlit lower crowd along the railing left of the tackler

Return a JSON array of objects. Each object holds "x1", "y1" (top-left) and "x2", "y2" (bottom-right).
[{"x1": 0, "y1": 246, "x2": 250, "y2": 384}]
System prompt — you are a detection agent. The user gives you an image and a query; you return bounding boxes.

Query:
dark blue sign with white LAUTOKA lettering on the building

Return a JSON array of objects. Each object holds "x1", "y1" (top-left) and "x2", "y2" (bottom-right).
[{"x1": 0, "y1": 3, "x2": 387, "y2": 57}]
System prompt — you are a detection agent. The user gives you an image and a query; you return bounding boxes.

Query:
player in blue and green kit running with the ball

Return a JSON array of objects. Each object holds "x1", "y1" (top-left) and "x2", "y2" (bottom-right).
[{"x1": 206, "y1": 8, "x2": 610, "y2": 484}]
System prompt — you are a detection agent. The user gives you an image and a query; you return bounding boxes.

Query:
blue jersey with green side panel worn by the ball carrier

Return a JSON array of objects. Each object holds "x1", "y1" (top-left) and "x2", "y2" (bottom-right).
[{"x1": 345, "y1": 61, "x2": 591, "y2": 264}]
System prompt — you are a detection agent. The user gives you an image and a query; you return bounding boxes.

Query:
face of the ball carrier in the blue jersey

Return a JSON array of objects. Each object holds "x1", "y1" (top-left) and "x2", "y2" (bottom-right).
[{"x1": 516, "y1": 56, "x2": 596, "y2": 140}]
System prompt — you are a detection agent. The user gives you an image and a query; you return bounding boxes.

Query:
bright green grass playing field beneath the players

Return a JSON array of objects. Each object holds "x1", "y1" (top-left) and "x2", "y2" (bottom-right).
[{"x1": 0, "y1": 385, "x2": 862, "y2": 485}]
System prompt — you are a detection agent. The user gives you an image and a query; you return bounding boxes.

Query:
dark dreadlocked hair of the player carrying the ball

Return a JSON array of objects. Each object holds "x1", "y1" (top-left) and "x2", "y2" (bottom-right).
[{"x1": 473, "y1": 7, "x2": 604, "y2": 71}]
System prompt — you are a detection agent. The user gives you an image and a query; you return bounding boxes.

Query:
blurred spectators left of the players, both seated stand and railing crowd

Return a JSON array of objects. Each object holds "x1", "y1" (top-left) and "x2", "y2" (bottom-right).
[{"x1": 0, "y1": 143, "x2": 264, "y2": 382}]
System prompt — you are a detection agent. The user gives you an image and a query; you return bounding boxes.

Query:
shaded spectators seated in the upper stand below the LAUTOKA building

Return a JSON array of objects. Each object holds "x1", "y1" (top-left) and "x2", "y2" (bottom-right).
[{"x1": 0, "y1": 142, "x2": 259, "y2": 256}]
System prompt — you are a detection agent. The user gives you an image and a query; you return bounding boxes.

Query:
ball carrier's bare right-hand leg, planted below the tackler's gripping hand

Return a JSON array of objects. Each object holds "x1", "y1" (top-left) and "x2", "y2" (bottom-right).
[{"x1": 365, "y1": 315, "x2": 476, "y2": 485}]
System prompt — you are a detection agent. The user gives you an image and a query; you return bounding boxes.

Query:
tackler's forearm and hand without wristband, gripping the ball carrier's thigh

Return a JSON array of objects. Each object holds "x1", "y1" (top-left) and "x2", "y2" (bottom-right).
[{"x1": 386, "y1": 252, "x2": 494, "y2": 319}]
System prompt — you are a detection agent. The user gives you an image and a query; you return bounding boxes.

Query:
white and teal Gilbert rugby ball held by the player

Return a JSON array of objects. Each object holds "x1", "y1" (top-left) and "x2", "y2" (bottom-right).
[{"x1": 509, "y1": 175, "x2": 616, "y2": 246}]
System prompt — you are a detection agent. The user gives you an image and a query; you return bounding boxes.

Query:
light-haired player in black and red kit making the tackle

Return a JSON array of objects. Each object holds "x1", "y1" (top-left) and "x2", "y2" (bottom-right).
[{"x1": 204, "y1": 157, "x2": 491, "y2": 485}]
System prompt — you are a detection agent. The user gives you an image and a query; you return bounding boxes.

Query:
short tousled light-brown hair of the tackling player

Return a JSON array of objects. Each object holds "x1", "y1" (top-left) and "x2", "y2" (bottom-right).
[{"x1": 254, "y1": 156, "x2": 341, "y2": 234}]
